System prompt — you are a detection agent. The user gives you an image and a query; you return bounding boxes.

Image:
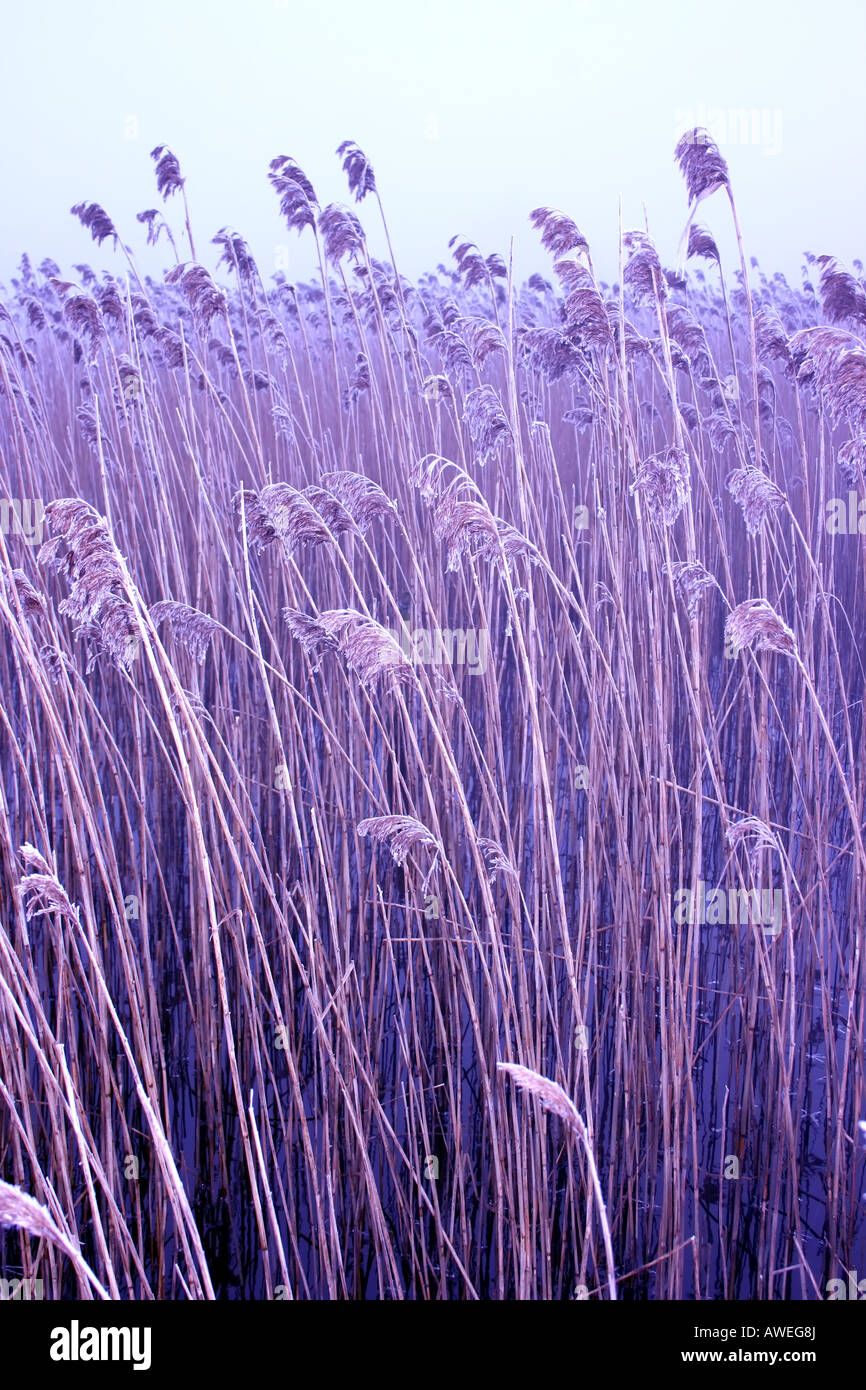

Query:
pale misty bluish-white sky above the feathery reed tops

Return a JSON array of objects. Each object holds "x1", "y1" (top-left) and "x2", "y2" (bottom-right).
[{"x1": 0, "y1": 0, "x2": 866, "y2": 281}]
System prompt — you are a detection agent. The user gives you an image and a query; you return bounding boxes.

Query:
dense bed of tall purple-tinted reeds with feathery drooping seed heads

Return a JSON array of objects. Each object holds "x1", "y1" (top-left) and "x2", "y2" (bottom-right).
[{"x1": 0, "y1": 138, "x2": 866, "y2": 1300}]
